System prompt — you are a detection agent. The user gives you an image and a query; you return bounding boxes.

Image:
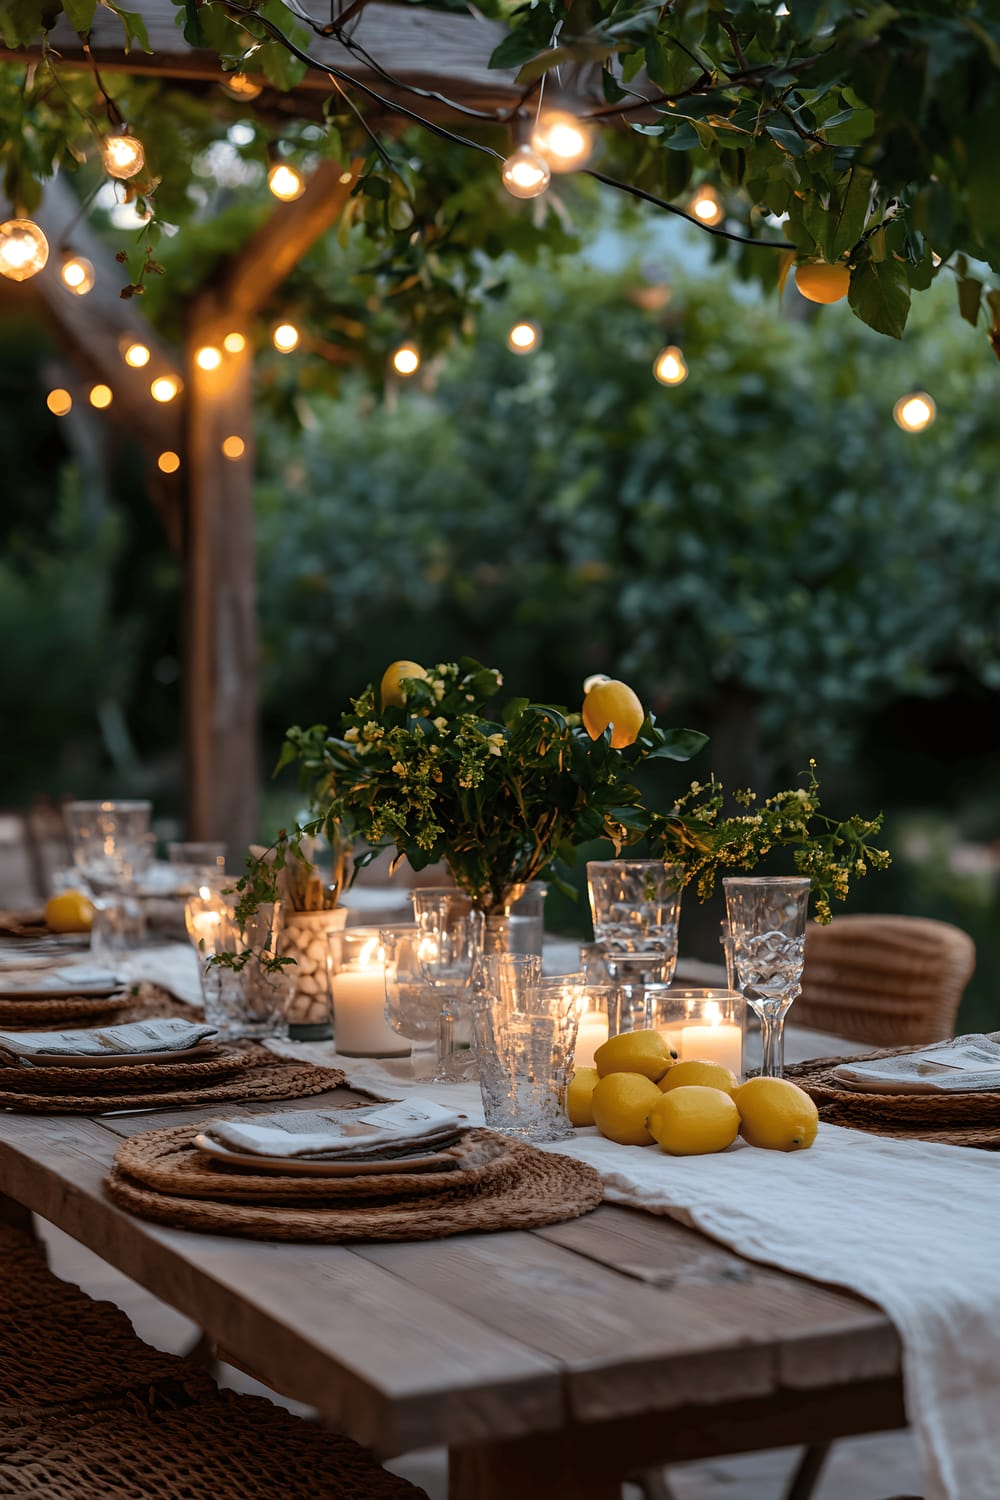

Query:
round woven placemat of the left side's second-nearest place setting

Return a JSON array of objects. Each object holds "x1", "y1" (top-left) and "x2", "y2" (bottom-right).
[{"x1": 0, "y1": 1053, "x2": 346, "y2": 1115}]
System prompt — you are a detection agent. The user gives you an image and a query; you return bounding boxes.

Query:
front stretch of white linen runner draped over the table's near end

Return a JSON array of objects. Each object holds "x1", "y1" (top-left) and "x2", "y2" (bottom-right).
[{"x1": 552, "y1": 1125, "x2": 1000, "y2": 1500}]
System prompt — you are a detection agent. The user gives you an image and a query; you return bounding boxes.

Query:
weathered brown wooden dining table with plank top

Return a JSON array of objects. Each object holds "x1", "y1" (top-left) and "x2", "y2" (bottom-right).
[{"x1": 0, "y1": 1068, "x2": 906, "y2": 1500}]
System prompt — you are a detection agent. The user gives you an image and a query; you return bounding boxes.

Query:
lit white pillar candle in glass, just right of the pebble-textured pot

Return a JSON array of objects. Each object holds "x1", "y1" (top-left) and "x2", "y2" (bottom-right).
[{"x1": 327, "y1": 927, "x2": 409, "y2": 1058}]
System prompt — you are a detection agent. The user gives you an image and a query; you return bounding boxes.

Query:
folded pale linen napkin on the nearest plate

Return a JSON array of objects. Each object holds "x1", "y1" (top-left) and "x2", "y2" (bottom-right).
[{"x1": 204, "y1": 1100, "x2": 468, "y2": 1161}]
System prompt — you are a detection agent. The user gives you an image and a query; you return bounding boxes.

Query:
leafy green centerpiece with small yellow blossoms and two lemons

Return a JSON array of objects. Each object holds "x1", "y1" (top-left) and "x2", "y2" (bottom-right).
[{"x1": 237, "y1": 657, "x2": 889, "y2": 948}]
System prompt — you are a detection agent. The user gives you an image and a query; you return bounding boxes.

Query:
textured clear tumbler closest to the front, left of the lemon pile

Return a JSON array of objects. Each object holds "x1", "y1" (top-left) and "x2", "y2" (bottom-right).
[{"x1": 474, "y1": 954, "x2": 583, "y2": 1142}]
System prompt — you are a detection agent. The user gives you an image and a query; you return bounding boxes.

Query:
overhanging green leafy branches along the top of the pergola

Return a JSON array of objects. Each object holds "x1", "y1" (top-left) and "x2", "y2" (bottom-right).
[{"x1": 0, "y1": 0, "x2": 1000, "y2": 354}]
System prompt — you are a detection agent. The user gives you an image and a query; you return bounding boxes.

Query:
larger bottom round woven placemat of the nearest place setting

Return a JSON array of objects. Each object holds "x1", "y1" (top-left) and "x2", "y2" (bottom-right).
[{"x1": 105, "y1": 1130, "x2": 601, "y2": 1245}]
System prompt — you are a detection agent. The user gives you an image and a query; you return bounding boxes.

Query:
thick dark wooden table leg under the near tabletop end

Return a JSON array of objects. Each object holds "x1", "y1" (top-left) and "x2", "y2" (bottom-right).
[{"x1": 448, "y1": 1433, "x2": 627, "y2": 1500}]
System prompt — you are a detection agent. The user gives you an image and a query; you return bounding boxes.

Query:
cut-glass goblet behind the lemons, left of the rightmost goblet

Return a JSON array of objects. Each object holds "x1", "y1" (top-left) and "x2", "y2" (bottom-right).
[{"x1": 586, "y1": 860, "x2": 684, "y2": 1031}]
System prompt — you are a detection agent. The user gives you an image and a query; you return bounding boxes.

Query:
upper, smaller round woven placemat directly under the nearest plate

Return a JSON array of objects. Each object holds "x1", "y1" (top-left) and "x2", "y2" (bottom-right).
[{"x1": 115, "y1": 1125, "x2": 519, "y2": 1206}]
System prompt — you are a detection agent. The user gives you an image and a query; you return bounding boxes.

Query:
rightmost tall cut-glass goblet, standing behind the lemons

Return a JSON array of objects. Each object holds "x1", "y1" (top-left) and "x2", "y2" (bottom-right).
[{"x1": 723, "y1": 875, "x2": 813, "y2": 1079}]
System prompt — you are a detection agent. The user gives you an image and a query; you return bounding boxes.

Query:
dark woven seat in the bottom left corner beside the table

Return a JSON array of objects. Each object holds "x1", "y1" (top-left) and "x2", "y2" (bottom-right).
[{"x1": 0, "y1": 1224, "x2": 427, "y2": 1500}]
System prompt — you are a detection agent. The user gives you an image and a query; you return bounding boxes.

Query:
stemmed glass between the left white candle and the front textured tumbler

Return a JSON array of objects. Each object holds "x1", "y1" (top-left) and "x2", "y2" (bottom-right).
[{"x1": 409, "y1": 887, "x2": 484, "y2": 1077}]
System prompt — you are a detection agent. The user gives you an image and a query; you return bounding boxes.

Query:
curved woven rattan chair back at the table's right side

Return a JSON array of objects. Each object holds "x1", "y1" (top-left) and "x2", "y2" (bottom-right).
[{"x1": 793, "y1": 915, "x2": 976, "y2": 1047}]
